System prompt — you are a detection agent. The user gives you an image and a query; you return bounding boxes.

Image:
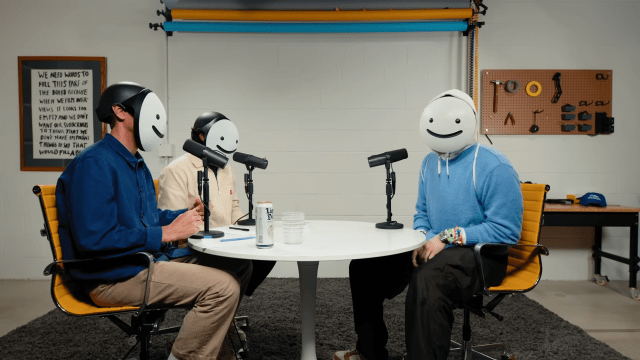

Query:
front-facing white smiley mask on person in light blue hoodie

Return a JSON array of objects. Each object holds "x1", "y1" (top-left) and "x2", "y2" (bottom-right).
[{"x1": 420, "y1": 89, "x2": 478, "y2": 154}]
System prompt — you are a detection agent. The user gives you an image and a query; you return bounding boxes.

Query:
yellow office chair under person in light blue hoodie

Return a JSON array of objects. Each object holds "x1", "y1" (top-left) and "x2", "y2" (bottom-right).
[{"x1": 449, "y1": 184, "x2": 549, "y2": 360}]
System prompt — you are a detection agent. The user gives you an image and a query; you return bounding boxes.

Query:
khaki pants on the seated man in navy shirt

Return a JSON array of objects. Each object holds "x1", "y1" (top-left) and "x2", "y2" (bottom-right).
[{"x1": 89, "y1": 254, "x2": 252, "y2": 360}]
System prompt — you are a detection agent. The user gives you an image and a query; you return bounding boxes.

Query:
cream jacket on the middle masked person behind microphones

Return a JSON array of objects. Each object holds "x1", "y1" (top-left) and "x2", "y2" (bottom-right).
[{"x1": 158, "y1": 154, "x2": 244, "y2": 229}]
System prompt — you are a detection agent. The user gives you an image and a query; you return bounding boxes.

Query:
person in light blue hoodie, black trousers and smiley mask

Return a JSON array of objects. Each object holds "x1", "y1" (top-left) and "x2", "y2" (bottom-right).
[{"x1": 334, "y1": 90, "x2": 524, "y2": 360}]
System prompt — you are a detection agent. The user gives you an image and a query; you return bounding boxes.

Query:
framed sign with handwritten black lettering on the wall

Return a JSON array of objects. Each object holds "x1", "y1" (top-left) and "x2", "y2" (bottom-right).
[{"x1": 18, "y1": 56, "x2": 107, "y2": 171}]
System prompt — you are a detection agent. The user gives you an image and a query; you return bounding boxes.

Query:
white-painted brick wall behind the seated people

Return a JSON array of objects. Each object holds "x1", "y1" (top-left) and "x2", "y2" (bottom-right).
[{"x1": 0, "y1": 0, "x2": 640, "y2": 279}]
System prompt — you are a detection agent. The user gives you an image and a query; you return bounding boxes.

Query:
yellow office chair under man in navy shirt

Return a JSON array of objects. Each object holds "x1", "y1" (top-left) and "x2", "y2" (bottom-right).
[{"x1": 33, "y1": 181, "x2": 180, "y2": 360}]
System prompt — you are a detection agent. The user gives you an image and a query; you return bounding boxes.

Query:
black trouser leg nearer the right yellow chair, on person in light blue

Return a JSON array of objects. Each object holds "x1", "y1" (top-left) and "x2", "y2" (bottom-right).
[{"x1": 405, "y1": 248, "x2": 506, "y2": 360}]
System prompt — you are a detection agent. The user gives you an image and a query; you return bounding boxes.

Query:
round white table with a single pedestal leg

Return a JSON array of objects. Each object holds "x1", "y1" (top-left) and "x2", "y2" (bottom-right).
[{"x1": 189, "y1": 220, "x2": 425, "y2": 360}]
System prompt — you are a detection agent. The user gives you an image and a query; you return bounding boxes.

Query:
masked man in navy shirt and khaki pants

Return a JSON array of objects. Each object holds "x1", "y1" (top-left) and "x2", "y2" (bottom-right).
[{"x1": 56, "y1": 83, "x2": 251, "y2": 360}]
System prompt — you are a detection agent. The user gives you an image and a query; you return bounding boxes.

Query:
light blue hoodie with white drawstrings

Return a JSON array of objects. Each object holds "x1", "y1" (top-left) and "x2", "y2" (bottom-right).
[{"x1": 413, "y1": 143, "x2": 524, "y2": 246}]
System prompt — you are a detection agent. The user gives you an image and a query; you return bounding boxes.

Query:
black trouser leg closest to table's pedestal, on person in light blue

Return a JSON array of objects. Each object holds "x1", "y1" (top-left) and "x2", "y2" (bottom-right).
[{"x1": 349, "y1": 252, "x2": 412, "y2": 360}]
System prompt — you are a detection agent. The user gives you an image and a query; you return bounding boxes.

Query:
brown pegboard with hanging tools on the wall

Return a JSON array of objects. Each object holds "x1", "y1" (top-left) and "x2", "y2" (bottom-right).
[{"x1": 481, "y1": 70, "x2": 613, "y2": 135}]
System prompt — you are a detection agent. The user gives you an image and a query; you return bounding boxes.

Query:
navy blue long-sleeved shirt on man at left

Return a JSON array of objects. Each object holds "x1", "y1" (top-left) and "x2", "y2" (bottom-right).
[{"x1": 56, "y1": 134, "x2": 189, "y2": 281}]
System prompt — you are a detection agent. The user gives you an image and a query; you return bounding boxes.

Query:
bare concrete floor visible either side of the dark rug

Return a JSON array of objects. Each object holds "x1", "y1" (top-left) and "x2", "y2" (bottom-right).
[{"x1": 0, "y1": 280, "x2": 640, "y2": 360}]
